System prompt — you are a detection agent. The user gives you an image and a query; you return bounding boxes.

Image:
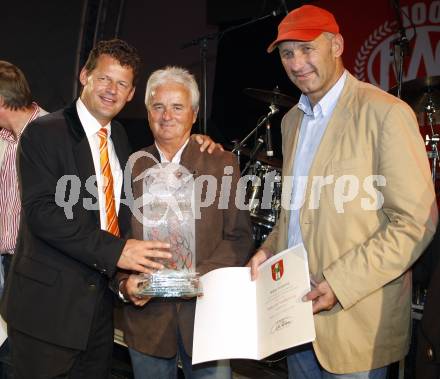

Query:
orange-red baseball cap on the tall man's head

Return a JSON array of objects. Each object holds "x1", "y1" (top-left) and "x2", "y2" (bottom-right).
[{"x1": 267, "y1": 5, "x2": 339, "y2": 53}]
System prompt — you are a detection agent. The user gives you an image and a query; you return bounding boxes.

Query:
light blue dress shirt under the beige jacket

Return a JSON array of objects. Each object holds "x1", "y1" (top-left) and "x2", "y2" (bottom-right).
[{"x1": 288, "y1": 71, "x2": 347, "y2": 247}]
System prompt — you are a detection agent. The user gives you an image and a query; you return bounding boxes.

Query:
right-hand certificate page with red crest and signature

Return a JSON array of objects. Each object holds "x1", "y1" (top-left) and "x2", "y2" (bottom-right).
[{"x1": 256, "y1": 245, "x2": 315, "y2": 359}]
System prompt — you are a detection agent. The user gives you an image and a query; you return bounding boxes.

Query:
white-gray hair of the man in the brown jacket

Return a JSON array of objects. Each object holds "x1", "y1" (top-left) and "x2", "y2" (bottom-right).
[{"x1": 145, "y1": 66, "x2": 200, "y2": 112}]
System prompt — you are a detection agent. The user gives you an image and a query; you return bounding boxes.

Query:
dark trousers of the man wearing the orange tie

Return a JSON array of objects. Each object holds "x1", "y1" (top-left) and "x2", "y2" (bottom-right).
[{"x1": 8, "y1": 290, "x2": 113, "y2": 379}]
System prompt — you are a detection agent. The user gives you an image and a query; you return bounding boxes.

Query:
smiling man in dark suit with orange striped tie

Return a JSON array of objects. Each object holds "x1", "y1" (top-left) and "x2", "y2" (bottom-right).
[{"x1": 1, "y1": 40, "x2": 175, "y2": 379}]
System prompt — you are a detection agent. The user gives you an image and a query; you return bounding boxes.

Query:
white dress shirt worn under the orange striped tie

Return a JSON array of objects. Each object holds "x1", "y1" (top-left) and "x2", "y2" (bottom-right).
[{"x1": 76, "y1": 99, "x2": 123, "y2": 230}]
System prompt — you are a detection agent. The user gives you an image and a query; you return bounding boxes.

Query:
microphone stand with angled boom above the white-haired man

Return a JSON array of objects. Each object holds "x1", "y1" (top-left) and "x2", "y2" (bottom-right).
[{"x1": 181, "y1": 8, "x2": 283, "y2": 135}]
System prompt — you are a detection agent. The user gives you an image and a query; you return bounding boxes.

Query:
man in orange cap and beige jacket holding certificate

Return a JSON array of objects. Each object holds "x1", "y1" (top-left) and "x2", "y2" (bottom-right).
[{"x1": 249, "y1": 5, "x2": 437, "y2": 379}]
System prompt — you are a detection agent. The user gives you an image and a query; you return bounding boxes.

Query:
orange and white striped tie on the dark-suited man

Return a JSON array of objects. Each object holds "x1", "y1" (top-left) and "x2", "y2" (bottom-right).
[{"x1": 98, "y1": 128, "x2": 120, "y2": 237}]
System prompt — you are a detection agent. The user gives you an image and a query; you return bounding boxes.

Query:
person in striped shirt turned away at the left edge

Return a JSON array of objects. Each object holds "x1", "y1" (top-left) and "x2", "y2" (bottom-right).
[{"x1": 0, "y1": 61, "x2": 47, "y2": 379}]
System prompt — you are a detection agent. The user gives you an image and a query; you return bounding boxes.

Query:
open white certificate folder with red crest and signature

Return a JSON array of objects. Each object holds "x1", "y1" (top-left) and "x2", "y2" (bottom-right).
[{"x1": 192, "y1": 245, "x2": 315, "y2": 364}]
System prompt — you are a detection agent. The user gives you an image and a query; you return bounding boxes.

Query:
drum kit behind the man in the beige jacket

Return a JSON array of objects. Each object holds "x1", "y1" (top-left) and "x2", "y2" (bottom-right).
[{"x1": 232, "y1": 76, "x2": 440, "y2": 247}]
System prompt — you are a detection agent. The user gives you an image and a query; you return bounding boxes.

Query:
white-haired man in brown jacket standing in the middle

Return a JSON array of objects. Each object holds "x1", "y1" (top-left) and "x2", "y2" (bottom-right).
[{"x1": 119, "y1": 67, "x2": 252, "y2": 379}]
